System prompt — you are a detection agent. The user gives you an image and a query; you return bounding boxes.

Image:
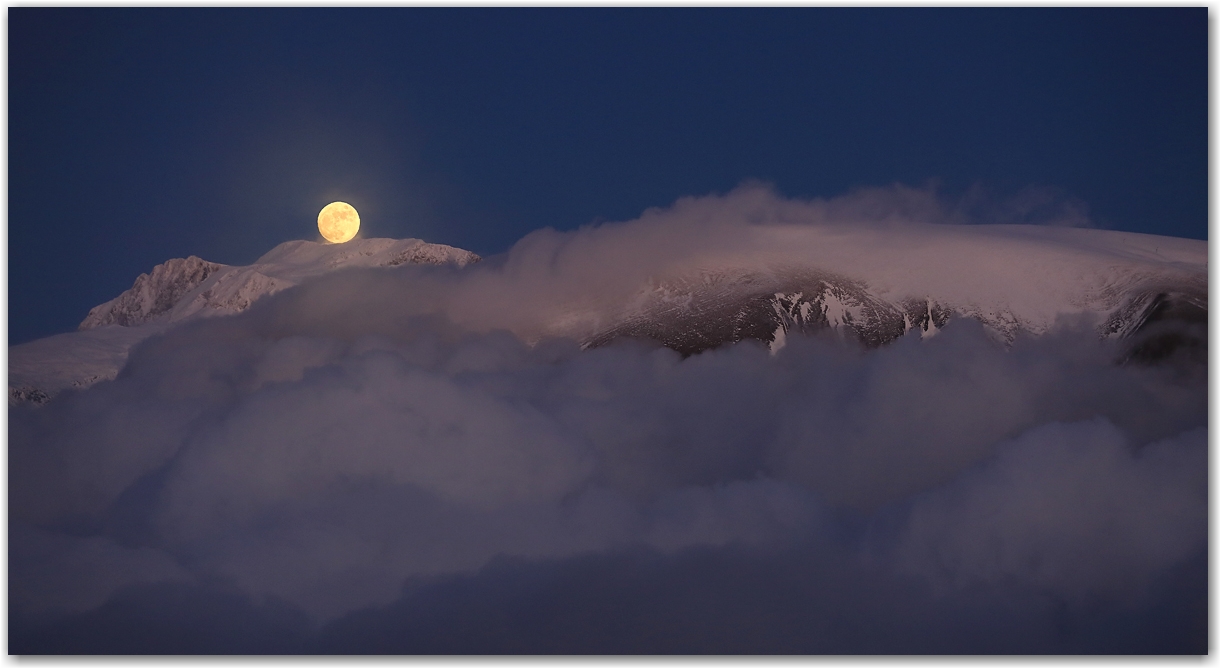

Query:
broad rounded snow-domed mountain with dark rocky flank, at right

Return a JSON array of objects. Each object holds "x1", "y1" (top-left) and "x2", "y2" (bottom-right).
[{"x1": 568, "y1": 224, "x2": 1208, "y2": 358}]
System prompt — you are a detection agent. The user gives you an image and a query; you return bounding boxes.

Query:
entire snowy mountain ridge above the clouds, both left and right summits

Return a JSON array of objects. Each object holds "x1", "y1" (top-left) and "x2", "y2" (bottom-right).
[{"x1": 9, "y1": 223, "x2": 1208, "y2": 405}]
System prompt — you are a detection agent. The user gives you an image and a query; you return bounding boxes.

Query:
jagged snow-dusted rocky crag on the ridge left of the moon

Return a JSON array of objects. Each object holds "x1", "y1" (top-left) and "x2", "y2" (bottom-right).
[{"x1": 79, "y1": 255, "x2": 224, "y2": 329}]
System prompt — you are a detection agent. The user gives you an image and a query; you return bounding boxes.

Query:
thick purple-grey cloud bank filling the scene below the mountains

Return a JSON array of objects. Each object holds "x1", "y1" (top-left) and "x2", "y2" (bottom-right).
[{"x1": 10, "y1": 190, "x2": 1208, "y2": 653}]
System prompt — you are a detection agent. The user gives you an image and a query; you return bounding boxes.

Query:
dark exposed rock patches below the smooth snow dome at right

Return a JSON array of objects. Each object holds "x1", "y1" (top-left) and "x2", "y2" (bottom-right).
[{"x1": 584, "y1": 265, "x2": 1208, "y2": 358}]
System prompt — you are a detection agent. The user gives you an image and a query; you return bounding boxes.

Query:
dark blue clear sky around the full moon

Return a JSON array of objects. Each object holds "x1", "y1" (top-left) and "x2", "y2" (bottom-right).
[{"x1": 9, "y1": 7, "x2": 1208, "y2": 344}]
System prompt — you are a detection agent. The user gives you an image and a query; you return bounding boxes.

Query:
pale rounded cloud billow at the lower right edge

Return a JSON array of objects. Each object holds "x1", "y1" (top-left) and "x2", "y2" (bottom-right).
[{"x1": 900, "y1": 419, "x2": 1208, "y2": 600}]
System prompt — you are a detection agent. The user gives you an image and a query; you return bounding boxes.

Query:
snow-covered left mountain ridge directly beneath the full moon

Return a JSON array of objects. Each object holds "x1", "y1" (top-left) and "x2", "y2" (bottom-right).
[{"x1": 9, "y1": 239, "x2": 481, "y2": 405}]
